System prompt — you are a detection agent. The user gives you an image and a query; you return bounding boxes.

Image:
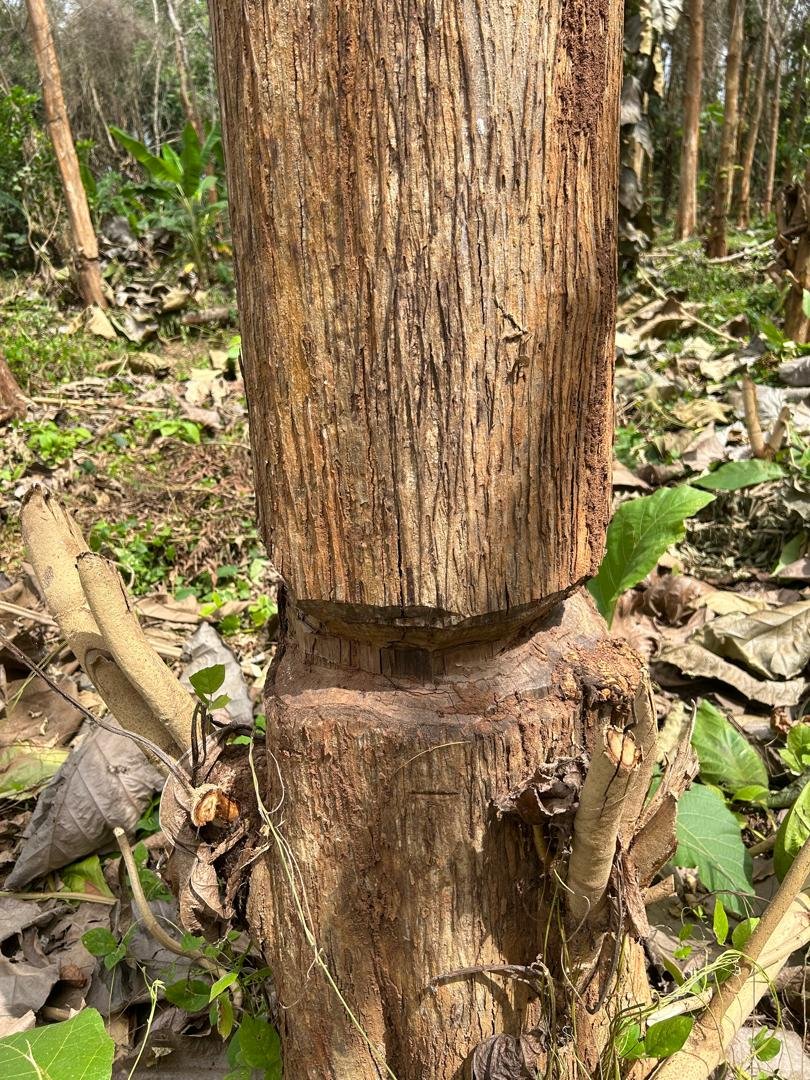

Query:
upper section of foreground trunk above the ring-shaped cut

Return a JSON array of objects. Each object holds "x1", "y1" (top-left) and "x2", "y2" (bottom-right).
[{"x1": 212, "y1": 0, "x2": 621, "y2": 638}]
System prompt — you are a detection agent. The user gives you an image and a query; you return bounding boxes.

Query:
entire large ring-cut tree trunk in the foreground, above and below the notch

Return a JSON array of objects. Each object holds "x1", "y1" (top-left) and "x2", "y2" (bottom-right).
[{"x1": 211, "y1": 0, "x2": 651, "y2": 1080}]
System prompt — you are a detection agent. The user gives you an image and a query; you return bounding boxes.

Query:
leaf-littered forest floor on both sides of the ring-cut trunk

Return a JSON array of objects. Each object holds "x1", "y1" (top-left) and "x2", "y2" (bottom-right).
[{"x1": 0, "y1": 223, "x2": 810, "y2": 1078}]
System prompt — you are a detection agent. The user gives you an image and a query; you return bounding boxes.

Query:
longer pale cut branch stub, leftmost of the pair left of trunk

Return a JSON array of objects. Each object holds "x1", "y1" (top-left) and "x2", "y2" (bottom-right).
[{"x1": 21, "y1": 485, "x2": 188, "y2": 755}]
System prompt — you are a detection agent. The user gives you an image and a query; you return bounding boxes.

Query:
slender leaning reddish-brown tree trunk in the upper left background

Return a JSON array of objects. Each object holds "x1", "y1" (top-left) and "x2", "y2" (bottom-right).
[{"x1": 26, "y1": 0, "x2": 107, "y2": 307}]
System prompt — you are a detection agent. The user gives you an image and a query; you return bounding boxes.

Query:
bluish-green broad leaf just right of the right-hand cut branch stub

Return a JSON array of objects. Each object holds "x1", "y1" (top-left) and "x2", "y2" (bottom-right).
[{"x1": 673, "y1": 784, "x2": 753, "y2": 915}]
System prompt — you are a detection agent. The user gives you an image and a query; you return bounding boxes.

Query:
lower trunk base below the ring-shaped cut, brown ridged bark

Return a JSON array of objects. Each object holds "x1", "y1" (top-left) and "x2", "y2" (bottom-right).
[{"x1": 248, "y1": 592, "x2": 646, "y2": 1080}]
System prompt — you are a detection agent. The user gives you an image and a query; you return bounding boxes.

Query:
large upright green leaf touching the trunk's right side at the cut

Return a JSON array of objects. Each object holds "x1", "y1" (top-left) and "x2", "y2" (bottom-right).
[{"x1": 588, "y1": 485, "x2": 714, "y2": 622}]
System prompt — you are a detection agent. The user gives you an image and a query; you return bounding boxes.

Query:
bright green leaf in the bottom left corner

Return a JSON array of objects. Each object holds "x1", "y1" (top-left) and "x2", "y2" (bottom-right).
[{"x1": 0, "y1": 1009, "x2": 114, "y2": 1080}]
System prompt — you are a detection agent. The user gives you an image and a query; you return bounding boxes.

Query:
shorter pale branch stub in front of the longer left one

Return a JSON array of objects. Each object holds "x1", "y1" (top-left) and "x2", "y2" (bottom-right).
[{"x1": 76, "y1": 551, "x2": 194, "y2": 748}]
